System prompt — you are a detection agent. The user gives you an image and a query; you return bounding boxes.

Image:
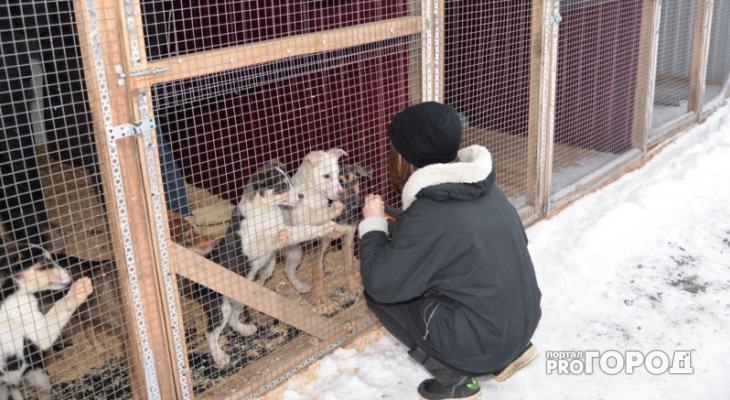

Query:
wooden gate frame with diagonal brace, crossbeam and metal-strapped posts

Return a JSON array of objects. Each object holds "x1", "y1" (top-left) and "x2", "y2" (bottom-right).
[{"x1": 75, "y1": 0, "x2": 427, "y2": 398}]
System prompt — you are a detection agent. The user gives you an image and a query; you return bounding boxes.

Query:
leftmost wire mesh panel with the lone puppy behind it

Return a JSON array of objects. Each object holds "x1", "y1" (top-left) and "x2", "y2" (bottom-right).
[{"x1": 0, "y1": 0, "x2": 154, "y2": 399}]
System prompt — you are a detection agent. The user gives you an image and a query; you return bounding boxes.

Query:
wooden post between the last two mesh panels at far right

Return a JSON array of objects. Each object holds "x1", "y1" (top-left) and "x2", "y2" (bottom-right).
[{"x1": 688, "y1": 0, "x2": 712, "y2": 115}]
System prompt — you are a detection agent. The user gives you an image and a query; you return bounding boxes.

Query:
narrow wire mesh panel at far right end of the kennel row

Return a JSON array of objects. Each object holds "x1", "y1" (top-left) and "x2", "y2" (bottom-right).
[{"x1": 703, "y1": 0, "x2": 730, "y2": 111}]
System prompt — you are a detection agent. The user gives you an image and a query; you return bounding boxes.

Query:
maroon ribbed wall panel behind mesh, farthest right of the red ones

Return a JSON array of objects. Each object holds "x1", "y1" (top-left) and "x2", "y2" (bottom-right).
[{"x1": 555, "y1": 0, "x2": 641, "y2": 153}]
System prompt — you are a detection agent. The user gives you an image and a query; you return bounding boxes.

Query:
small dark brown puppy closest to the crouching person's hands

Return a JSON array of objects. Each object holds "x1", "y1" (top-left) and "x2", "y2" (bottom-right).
[{"x1": 335, "y1": 164, "x2": 373, "y2": 292}]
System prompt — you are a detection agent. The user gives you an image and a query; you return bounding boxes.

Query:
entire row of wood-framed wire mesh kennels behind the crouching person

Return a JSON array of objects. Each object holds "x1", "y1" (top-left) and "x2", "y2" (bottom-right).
[{"x1": 0, "y1": 0, "x2": 730, "y2": 398}]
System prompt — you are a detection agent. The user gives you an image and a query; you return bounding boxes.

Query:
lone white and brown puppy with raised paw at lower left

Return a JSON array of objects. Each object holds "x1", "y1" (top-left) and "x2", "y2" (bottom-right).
[{"x1": 0, "y1": 244, "x2": 93, "y2": 400}]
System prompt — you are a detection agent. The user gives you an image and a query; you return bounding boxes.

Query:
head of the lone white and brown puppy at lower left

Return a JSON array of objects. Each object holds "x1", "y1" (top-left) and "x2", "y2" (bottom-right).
[{"x1": 0, "y1": 241, "x2": 71, "y2": 293}]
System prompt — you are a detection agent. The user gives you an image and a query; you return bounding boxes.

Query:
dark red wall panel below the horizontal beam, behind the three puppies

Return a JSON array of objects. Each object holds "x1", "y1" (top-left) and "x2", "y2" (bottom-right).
[{"x1": 153, "y1": 38, "x2": 409, "y2": 205}]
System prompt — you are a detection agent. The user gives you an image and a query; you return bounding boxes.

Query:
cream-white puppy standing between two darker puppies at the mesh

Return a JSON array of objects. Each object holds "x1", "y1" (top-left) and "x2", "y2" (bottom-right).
[{"x1": 285, "y1": 149, "x2": 347, "y2": 302}]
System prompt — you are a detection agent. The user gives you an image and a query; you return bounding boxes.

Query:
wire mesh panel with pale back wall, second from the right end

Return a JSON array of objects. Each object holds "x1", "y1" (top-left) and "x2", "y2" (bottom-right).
[{"x1": 649, "y1": 0, "x2": 697, "y2": 136}]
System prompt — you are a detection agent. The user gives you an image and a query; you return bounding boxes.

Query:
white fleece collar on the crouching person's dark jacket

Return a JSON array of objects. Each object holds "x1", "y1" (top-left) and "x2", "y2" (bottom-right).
[{"x1": 403, "y1": 145, "x2": 492, "y2": 210}]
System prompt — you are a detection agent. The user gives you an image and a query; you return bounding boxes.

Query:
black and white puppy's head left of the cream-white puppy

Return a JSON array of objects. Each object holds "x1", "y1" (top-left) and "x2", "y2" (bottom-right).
[{"x1": 251, "y1": 161, "x2": 304, "y2": 206}]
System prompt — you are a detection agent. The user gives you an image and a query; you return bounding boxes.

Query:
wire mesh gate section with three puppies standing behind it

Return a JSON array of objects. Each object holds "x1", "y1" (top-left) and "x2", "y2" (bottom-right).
[{"x1": 132, "y1": 1, "x2": 422, "y2": 398}]
